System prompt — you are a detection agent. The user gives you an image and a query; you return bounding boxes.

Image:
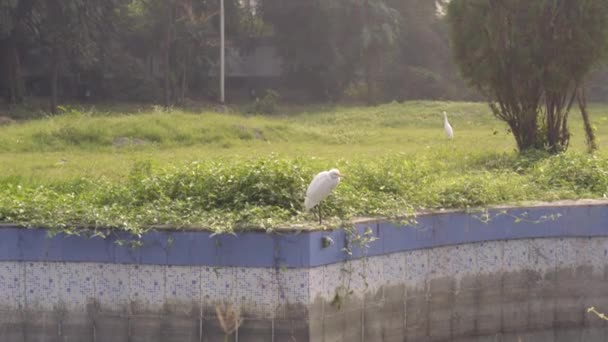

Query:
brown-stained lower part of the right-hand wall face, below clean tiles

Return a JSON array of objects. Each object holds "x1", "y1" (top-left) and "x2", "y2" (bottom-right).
[{"x1": 310, "y1": 267, "x2": 608, "y2": 342}]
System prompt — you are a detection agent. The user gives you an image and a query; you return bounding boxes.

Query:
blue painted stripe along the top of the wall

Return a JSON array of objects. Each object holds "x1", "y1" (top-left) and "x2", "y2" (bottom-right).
[{"x1": 0, "y1": 205, "x2": 608, "y2": 268}]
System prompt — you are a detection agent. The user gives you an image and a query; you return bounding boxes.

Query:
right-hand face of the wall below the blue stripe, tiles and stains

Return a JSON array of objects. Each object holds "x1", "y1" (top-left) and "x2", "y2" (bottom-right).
[{"x1": 310, "y1": 238, "x2": 608, "y2": 341}]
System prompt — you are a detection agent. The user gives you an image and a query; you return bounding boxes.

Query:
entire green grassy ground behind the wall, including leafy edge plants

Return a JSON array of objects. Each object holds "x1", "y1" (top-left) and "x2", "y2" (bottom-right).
[{"x1": 0, "y1": 102, "x2": 608, "y2": 235}]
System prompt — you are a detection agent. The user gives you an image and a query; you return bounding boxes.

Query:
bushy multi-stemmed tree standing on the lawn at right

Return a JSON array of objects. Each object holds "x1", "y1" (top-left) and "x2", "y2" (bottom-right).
[{"x1": 448, "y1": 0, "x2": 608, "y2": 153}]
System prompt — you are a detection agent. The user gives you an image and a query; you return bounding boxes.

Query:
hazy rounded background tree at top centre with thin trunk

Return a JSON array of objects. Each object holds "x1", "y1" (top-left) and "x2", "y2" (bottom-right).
[{"x1": 260, "y1": 0, "x2": 399, "y2": 102}]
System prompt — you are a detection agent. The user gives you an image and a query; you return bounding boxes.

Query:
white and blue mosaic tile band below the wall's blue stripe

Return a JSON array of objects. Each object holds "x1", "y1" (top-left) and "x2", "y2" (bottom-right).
[{"x1": 0, "y1": 238, "x2": 608, "y2": 318}]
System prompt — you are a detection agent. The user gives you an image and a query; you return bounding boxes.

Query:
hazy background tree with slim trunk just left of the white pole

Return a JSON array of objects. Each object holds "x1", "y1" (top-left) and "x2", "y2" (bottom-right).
[{"x1": 122, "y1": 0, "x2": 242, "y2": 106}]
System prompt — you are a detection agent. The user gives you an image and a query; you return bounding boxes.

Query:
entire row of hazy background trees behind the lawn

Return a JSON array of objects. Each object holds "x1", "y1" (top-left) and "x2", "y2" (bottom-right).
[{"x1": 0, "y1": 0, "x2": 608, "y2": 110}]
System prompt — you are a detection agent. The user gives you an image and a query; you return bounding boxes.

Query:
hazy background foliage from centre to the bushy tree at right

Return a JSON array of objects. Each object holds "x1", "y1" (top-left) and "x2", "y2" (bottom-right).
[{"x1": 260, "y1": 0, "x2": 470, "y2": 103}]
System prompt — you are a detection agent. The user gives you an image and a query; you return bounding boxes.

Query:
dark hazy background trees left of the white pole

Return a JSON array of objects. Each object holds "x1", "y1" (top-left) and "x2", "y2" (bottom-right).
[{"x1": 0, "y1": 0, "x2": 245, "y2": 107}]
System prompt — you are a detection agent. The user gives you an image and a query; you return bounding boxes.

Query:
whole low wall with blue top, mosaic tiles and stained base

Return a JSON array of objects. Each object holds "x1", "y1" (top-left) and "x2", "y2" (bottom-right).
[{"x1": 0, "y1": 200, "x2": 608, "y2": 342}]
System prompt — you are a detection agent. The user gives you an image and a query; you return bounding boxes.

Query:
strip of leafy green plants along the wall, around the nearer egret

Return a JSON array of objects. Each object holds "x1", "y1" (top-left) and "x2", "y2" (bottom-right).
[{"x1": 0, "y1": 154, "x2": 608, "y2": 234}]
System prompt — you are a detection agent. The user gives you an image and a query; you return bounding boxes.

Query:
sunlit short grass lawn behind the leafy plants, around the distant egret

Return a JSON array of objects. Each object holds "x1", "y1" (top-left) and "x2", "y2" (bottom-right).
[{"x1": 0, "y1": 102, "x2": 514, "y2": 181}]
